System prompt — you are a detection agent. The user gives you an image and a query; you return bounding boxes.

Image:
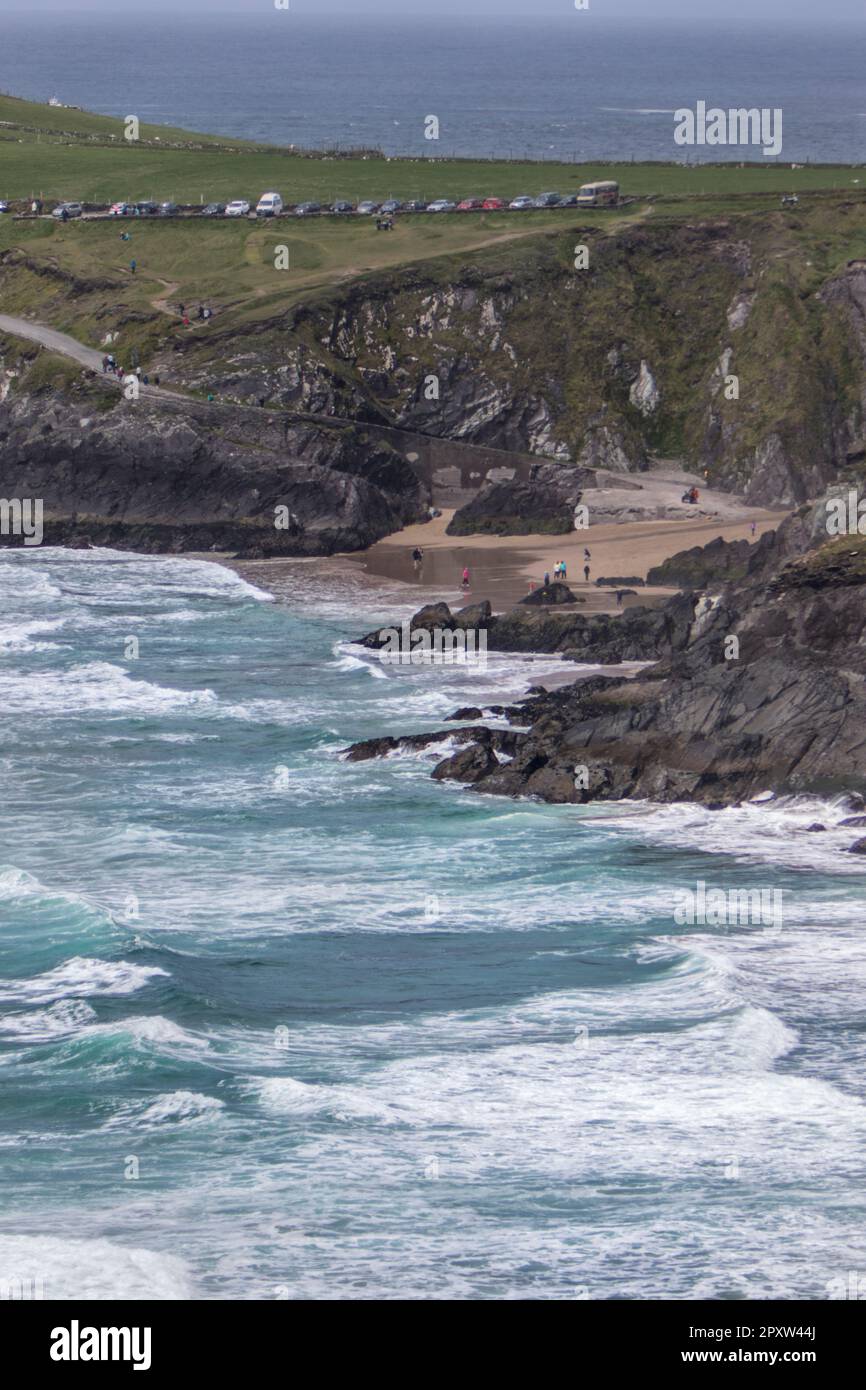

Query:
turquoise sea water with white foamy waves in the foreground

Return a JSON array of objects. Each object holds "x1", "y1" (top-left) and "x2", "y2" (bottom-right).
[{"x1": 0, "y1": 549, "x2": 866, "y2": 1298}]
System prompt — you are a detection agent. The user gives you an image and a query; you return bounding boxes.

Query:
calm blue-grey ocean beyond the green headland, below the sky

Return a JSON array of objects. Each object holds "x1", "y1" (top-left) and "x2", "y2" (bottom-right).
[{"x1": 0, "y1": 12, "x2": 866, "y2": 163}]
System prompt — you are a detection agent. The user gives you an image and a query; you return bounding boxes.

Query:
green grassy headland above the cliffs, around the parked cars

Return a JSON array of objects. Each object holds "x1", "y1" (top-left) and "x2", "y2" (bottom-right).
[{"x1": 0, "y1": 97, "x2": 866, "y2": 383}]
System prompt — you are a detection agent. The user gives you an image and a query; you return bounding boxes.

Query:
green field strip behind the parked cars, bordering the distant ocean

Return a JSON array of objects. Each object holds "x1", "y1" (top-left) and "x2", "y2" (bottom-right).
[{"x1": 0, "y1": 96, "x2": 866, "y2": 203}]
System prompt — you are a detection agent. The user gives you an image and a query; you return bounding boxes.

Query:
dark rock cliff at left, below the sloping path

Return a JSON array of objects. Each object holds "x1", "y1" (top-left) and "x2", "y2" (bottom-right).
[{"x1": 0, "y1": 345, "x2": 428, "y2": 555}]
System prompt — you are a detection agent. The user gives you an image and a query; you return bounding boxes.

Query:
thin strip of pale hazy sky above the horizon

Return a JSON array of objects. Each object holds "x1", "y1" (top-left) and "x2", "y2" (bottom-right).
[{"x1": 6, "y1": 0, "x2": 866, "y2": 17}]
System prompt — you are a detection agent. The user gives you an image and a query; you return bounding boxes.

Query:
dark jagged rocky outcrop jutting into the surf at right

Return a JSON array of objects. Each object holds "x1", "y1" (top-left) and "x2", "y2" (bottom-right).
[{"x1": 343, "y1": 509, "x2": 866, "y2": 805}]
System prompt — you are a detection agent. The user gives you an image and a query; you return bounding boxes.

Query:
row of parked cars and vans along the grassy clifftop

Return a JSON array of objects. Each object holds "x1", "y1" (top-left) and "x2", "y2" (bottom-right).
[{"x1": 25, "y1": 182, "x2": 620, "y2": 221}]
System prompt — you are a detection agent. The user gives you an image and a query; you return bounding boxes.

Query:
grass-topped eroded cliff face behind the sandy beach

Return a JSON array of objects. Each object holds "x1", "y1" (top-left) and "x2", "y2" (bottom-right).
[{"x1": 164, "y1": 211, "x2": 866, "y2": 505}]
